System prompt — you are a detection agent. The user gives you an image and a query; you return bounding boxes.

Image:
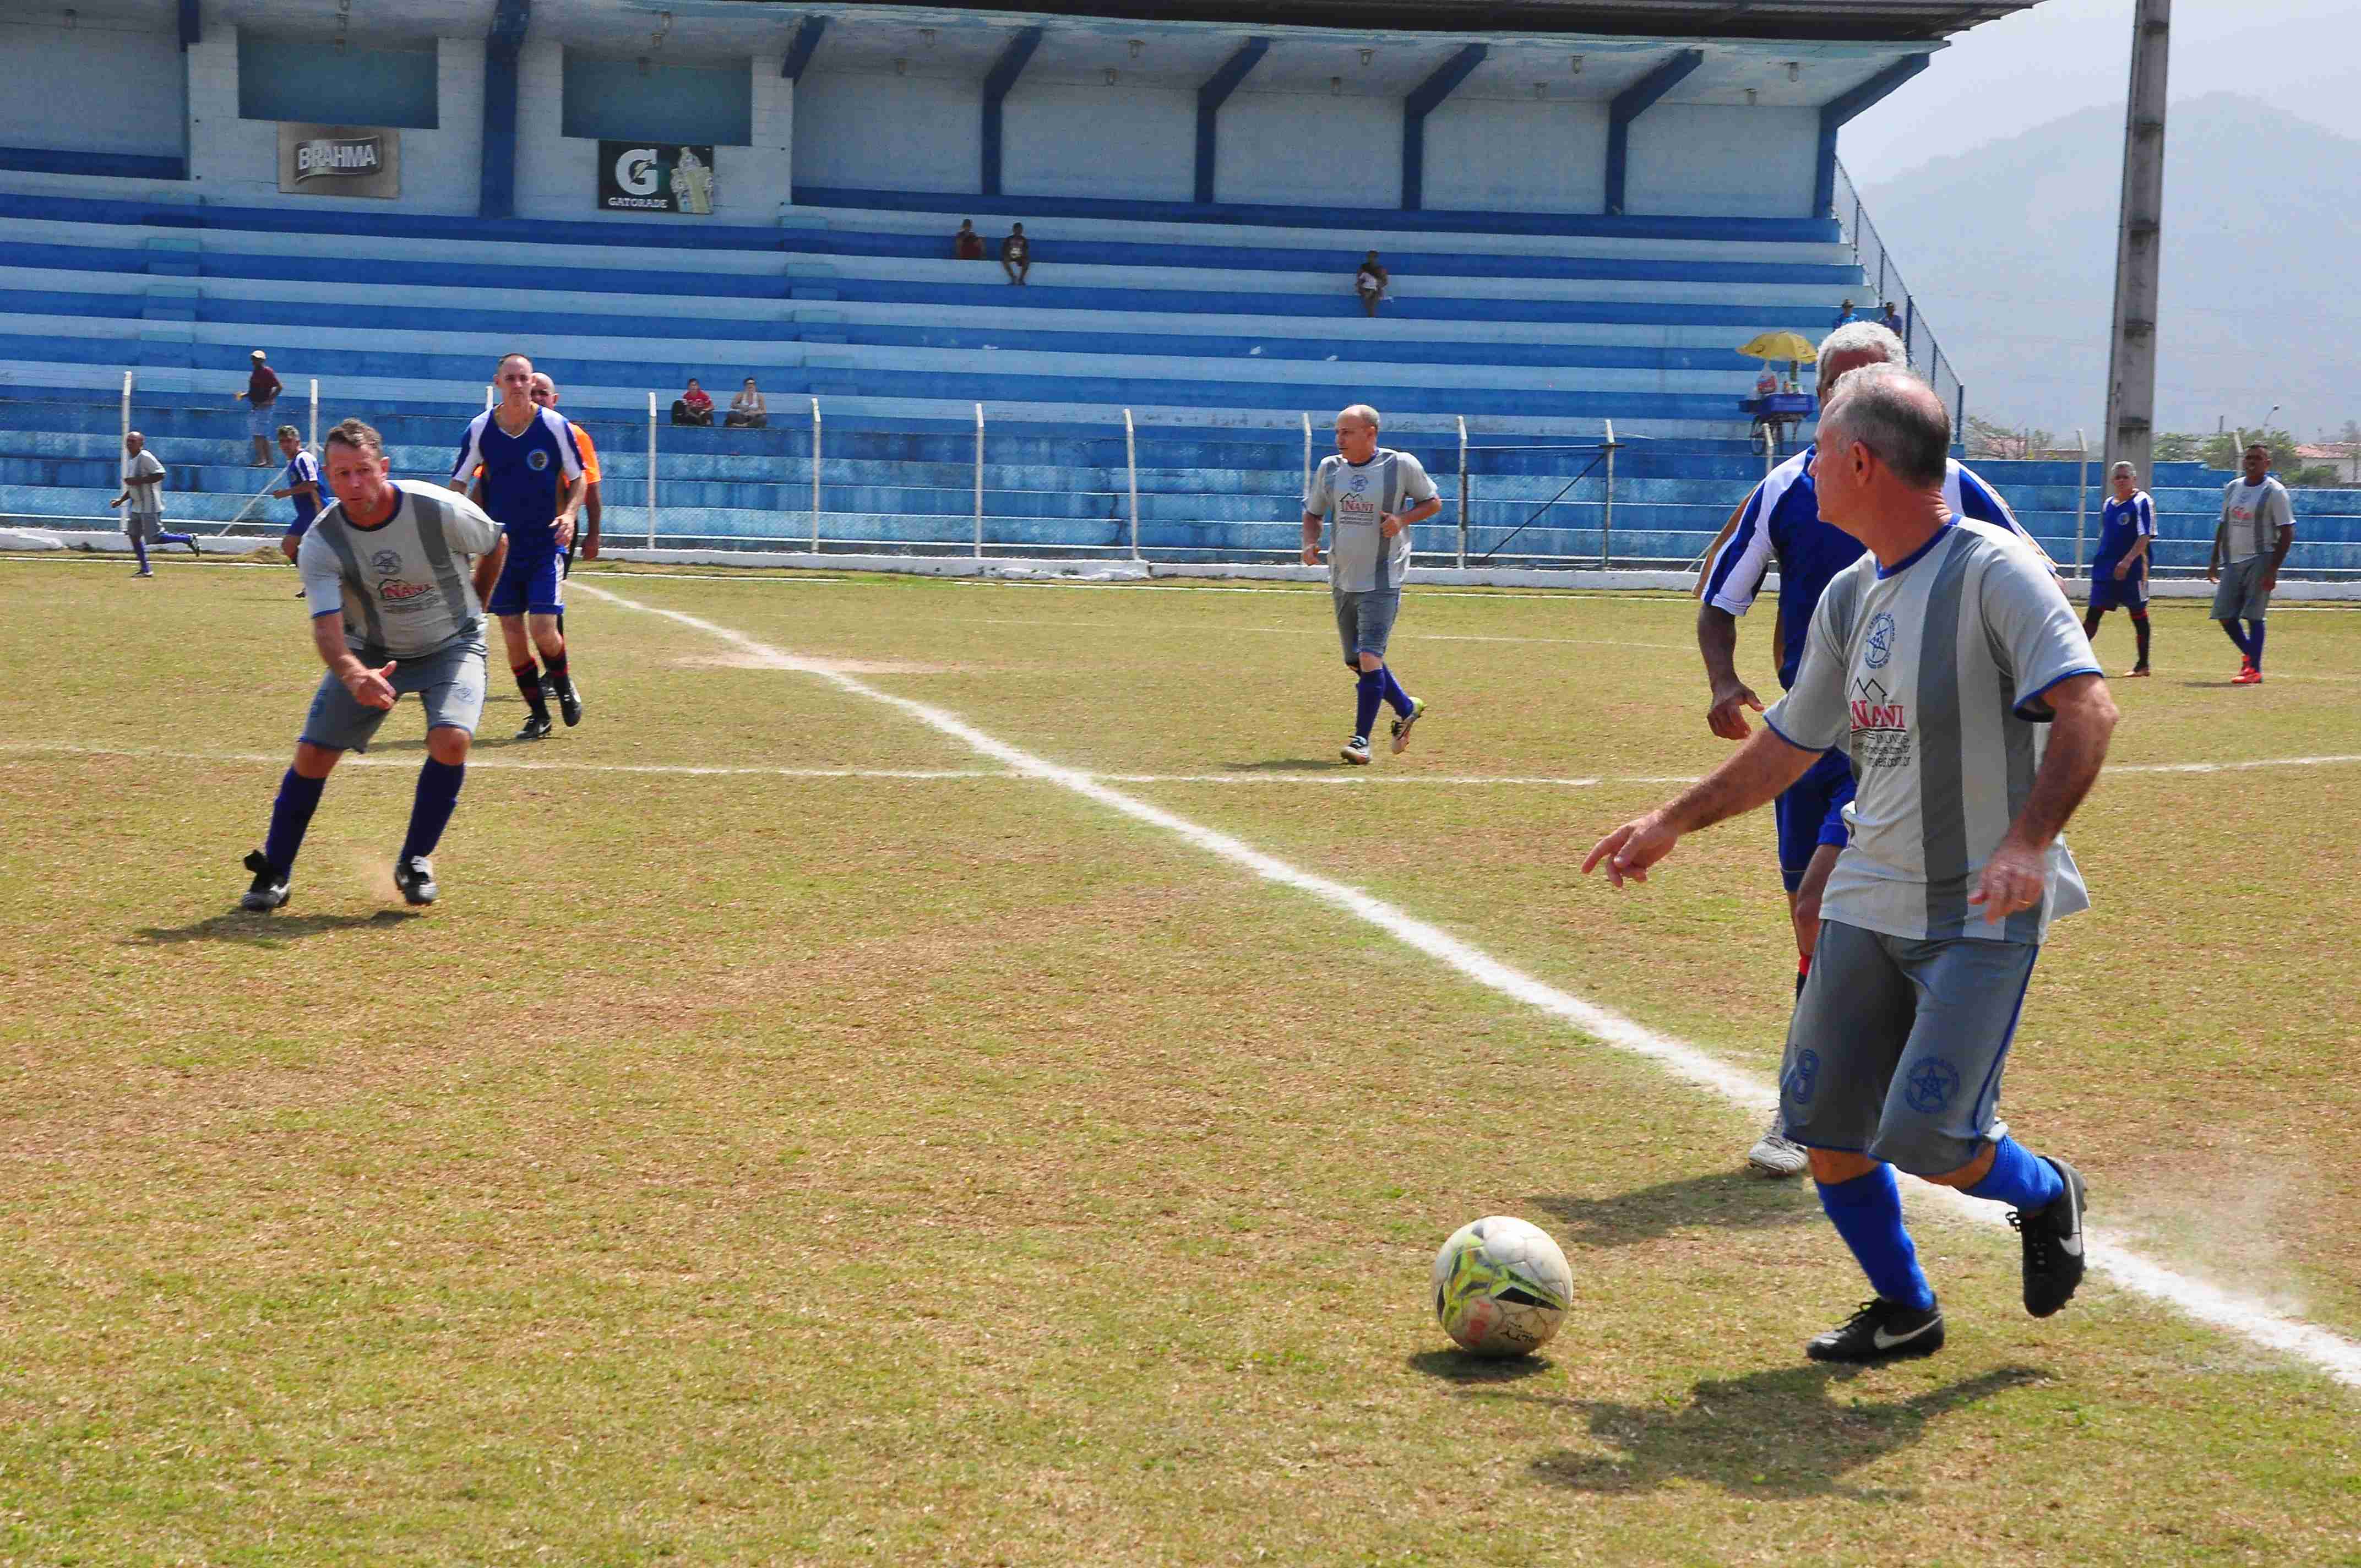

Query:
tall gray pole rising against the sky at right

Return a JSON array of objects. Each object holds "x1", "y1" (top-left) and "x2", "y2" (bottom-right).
[{"x1": 2104, "y1": 0, "x2": 2172, "y2": 480}]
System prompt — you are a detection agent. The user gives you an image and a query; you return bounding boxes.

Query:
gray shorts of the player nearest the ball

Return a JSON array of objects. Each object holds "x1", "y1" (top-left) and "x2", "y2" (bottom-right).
[{"x1": 1778, "y1": 921, "x2": 2040, "y2": 1176}]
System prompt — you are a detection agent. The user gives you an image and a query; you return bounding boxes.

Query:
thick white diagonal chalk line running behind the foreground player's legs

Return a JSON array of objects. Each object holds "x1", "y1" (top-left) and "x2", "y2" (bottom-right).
[{"x1": 579, "y1": 583, "x2": 2361, "y2": 1389}]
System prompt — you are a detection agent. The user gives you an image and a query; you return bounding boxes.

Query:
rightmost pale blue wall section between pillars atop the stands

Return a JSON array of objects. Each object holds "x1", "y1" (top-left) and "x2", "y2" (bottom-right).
[{"x1": 1624, "y1": 104, "x2": 1820, "y2": 217}]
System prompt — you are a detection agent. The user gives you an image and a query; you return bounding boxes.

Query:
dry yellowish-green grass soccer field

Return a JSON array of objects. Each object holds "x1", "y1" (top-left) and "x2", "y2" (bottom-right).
[{"x1": 0, "y1": 560, "x2": 2361, "y2": 1566}]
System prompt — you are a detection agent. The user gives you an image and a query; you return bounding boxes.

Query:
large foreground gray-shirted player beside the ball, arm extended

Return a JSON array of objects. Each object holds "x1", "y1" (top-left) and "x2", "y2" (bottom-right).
[{"x1": 1582, "y1": 366, "x2": 2115, "y2": 1363}]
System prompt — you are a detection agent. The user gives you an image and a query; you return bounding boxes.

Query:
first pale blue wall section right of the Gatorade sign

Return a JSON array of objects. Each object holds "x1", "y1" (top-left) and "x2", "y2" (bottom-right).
[{"x1": 793, "y1": 66, "x2": 977, "y2": 194}]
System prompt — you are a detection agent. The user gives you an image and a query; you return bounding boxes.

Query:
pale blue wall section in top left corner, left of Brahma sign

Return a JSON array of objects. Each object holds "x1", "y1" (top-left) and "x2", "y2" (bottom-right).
[{"x1": 0, "y1": 7, "x2": 189, "y2": 158}]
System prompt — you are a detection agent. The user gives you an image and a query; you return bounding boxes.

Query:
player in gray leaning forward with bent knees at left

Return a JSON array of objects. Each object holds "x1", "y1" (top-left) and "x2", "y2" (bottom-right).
[{"x1": 241, "y1": 420, "x2": 508, "y2": 909}]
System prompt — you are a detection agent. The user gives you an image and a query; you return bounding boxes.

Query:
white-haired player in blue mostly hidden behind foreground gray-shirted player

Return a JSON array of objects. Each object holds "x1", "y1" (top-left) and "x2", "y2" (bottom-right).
[{"x1": 1698, "y1": 321, "x2": 2031, "y2": 1176}]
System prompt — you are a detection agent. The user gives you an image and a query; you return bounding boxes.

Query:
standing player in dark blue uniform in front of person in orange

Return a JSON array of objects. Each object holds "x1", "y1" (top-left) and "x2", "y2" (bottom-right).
[{"x1": 451, "y1": 354, "x2": 583, "y2": 742}]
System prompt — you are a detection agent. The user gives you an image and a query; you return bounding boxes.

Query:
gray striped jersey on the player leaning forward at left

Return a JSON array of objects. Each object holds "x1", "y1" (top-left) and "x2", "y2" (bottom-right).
[{"x1": 295, "y1": 480, "x2": 501, "y2": 663}]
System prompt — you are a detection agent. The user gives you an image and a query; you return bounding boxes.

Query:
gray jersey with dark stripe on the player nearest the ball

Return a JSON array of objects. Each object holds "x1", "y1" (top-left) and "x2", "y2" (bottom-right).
[{"x1": 1764, "y1": 522, "x2": 2099, "y2": 942}]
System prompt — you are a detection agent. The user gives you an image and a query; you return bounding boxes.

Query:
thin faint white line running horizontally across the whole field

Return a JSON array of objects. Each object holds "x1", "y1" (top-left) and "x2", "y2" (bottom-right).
[{"x1": 18, "y1": 746, "x2": 2361, "y2": 789}]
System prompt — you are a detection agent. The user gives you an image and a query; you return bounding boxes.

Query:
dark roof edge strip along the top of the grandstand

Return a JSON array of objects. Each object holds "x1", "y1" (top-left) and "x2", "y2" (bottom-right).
[{"x1": 840, "y1": 0, "x2": 2038, "y2": 42}]
